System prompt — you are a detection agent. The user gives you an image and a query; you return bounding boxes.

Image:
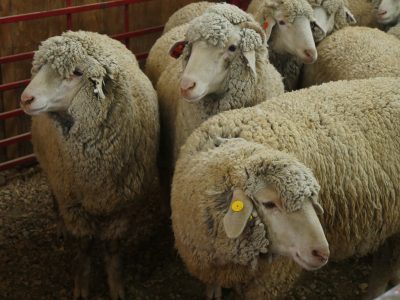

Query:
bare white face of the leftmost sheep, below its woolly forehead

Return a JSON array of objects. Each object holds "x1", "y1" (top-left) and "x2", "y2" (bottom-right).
[{"x1": 21, "y1": 64, "x2": 84, "y2": 116}]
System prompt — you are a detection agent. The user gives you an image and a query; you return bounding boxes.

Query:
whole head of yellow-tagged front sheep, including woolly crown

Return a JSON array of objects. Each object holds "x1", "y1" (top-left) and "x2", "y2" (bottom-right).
[{"x1": 223, "y1": 142, "x2": 329, "y2": 270}]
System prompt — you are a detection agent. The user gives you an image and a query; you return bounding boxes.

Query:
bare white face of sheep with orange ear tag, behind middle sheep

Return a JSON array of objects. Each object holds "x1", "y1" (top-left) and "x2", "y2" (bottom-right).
[{"x1": 264, "y1": 11, "x2": 323, "y2": 64}]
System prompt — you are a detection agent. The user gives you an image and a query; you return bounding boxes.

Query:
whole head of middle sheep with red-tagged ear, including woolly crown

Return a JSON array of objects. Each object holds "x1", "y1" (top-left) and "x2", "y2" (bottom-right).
[{"x1": 170, "y1": 4, "x2": 265, "y2": 102}]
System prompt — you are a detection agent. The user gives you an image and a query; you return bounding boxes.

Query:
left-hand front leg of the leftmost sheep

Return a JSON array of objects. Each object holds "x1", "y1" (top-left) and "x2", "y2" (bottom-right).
[{"x1": 73, "y1": 237, "x2": 93, "y2": 300}]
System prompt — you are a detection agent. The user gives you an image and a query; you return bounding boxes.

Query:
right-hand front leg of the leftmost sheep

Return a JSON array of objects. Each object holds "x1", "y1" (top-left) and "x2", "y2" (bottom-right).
[{"x1": 105, "y1": 240, "x2": 125, "y2": 300}]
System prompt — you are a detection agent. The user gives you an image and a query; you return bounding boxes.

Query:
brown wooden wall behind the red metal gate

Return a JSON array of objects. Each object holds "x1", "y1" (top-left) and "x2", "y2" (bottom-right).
[{"x1": 0, "y1": 0, "x2": 212, "y2": 162}]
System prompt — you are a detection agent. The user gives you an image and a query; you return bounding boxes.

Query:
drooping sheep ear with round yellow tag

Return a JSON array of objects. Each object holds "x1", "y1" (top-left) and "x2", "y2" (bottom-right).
[{"x1": 223, "y1": 190, "x2": 253, "y2": 239}]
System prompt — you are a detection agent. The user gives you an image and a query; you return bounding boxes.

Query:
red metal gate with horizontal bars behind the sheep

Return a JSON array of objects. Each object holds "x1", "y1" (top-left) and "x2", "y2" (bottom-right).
[{"x1": 0, "y1": 0, "x2": 249, "y2": 171}]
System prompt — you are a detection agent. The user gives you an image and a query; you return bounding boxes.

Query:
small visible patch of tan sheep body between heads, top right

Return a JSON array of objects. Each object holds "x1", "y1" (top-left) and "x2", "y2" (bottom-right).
[{"x1": 348, "y1": 0, "x2": 378, "y2": 28}]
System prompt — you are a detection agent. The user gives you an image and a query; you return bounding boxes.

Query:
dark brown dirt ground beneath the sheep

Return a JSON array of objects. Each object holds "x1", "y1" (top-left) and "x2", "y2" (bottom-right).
[{"x1": 0, "y1": 167, "x2": 371, "y2": 300}]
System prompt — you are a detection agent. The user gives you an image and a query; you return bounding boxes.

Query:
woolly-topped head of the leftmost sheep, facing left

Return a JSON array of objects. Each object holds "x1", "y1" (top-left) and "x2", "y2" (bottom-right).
[{"x1": 21, "y1": 31, "x2": 119, "y2": 115}]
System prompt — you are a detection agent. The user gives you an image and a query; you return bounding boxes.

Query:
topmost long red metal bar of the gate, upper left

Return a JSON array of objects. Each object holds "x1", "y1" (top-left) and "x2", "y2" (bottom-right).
[{"x1": 0, "y1": 0, "x2": 150, "y2": 24}]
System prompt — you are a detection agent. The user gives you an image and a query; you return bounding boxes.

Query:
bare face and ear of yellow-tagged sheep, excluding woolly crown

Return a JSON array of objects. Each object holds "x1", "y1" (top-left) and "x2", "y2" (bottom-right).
[{"x1": 223, "y1": 187, "x2": 329, "y2": 270}]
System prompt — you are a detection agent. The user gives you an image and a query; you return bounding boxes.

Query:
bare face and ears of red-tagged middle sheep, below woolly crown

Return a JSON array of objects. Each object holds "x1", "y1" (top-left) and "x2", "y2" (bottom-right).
[{"x1": 170, "y1": 22, "x2": 265, "y2": 102}]
